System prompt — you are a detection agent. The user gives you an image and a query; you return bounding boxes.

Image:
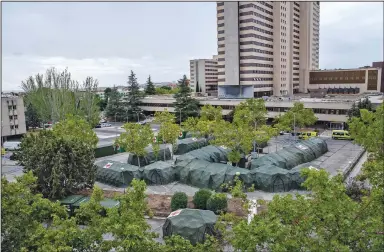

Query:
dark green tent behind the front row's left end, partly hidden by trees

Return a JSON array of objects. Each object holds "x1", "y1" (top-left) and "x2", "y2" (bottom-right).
[{"x1": 127, "y1": 146, "x2": 171, "y2": 167}]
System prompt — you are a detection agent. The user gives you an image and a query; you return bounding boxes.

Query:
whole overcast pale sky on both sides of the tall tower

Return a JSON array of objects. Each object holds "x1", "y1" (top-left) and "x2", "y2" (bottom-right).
[{"x1": 2, "y1": 2, "x2": 383, "y2": 90}]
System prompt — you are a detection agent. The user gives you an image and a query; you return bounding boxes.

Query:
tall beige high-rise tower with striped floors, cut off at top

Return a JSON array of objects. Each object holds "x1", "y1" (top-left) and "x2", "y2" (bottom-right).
[{"x1": 217, "y1": 1, "x2": 320, "y2": 98}]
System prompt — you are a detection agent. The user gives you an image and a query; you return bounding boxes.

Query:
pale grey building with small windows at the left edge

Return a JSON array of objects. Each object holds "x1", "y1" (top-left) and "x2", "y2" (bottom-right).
[{"x1": 1, "y1": 96, "x2": 27, "y2": 141}]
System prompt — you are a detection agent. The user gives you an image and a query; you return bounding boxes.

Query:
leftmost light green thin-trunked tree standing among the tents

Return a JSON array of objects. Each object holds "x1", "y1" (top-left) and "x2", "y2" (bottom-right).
[{"x1": 115, "y1": 123, "x2": 154, "y2": 167}]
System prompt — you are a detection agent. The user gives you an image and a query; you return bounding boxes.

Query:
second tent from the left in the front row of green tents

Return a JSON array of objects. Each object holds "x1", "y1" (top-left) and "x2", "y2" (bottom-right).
[{"x1": 143, "y1": 161, "x2": 175, "y2": 185}]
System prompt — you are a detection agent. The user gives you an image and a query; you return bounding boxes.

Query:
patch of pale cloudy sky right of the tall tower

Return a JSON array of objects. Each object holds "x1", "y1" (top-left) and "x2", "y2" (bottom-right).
[{"x1": 319, "y1": 2, "x2": 383, "y2": 69}]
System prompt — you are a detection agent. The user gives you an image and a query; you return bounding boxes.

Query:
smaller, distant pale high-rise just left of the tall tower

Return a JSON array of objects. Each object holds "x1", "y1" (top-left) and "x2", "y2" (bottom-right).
[{"x1": 189, "y1": 55, "x2": 217, "y2": 96}]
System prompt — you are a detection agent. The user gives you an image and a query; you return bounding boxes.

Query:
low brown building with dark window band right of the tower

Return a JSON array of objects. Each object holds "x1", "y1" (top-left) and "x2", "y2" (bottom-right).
[{"x1": 304, "y1": 68, "x2": 382, "y2": 94}]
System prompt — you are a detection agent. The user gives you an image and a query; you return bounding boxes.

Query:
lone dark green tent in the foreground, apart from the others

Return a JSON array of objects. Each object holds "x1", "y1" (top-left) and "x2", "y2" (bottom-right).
[{"x1": 163, "y1": 209, "x2": 217, "y2": 245}]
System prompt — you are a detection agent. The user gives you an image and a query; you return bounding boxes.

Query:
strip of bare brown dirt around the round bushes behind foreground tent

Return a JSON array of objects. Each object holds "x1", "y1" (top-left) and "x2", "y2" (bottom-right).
[{"x1": 78, "y1": 189, "x2": 246, "y2": 217}]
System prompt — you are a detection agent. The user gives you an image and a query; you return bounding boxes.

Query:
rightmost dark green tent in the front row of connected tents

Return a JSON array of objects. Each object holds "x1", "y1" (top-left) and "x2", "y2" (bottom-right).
[{"x1": 250, "y1": 165, "x2": 291, "y2": 192}]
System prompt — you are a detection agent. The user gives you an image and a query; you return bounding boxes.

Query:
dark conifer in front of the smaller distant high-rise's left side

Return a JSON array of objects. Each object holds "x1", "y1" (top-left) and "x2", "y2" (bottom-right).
[{"x1": 174, "y1": 75, "x2": 200, "y2": 124}]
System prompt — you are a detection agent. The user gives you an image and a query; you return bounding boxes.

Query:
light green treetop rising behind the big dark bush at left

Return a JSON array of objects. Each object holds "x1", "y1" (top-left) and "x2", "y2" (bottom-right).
[{"x1": 52, "y1": 115, "x2": 99, "y2": 148}]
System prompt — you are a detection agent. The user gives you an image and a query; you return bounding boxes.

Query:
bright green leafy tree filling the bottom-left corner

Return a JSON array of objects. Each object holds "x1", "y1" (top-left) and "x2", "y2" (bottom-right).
[{"x1": 1, "y1": 172, "x2": 66, "y2": 252}]
